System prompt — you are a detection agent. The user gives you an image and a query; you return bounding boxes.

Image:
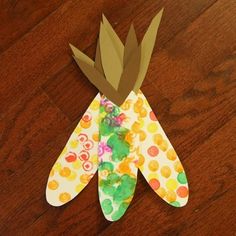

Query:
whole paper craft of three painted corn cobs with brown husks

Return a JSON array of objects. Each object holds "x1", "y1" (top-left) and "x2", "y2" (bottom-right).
[{"x1": 46, "y1": 11, "x2": 188, "y2": 221}]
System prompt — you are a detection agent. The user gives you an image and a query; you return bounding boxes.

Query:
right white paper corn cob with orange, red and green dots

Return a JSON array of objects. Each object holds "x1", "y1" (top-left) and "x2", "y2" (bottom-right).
[{"x1": 138, "y1": 92, "x2": 188, "y2": 207}]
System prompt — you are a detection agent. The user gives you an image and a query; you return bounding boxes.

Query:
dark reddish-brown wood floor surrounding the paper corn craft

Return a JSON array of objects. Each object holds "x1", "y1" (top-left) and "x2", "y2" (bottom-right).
[{"x1": 0, "y1": 0, "x2": 236, "y2": 236}]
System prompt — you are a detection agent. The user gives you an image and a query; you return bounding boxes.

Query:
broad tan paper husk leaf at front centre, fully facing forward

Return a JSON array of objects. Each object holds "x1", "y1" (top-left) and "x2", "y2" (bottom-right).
[{"x1": 99, "y1": 24, "x2": 123, "y2": 89}]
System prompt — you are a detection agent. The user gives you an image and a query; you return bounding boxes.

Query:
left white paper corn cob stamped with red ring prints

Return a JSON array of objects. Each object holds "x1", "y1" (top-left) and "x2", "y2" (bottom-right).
[{"x1": 46, "y1": 94, "x2": 100, "y2": 206}]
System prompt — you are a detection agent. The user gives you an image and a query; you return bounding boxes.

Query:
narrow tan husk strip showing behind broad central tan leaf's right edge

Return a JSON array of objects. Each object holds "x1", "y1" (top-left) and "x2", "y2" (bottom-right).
[{"x1": 102, "y1": 15, "x2": 124, "y2": 65}]
